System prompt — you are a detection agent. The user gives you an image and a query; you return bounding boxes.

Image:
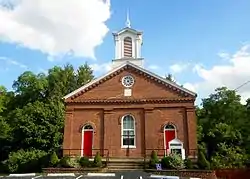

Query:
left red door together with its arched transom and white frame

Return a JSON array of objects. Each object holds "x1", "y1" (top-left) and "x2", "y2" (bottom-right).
[{"x1": 82, "y1": 125, "x2": 94, "y2": 157}]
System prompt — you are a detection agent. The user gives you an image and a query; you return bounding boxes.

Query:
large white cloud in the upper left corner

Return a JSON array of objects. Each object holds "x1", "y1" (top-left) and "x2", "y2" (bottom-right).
[{"x1": 0, "y1": 0, "x2": 111, "y2": 59}]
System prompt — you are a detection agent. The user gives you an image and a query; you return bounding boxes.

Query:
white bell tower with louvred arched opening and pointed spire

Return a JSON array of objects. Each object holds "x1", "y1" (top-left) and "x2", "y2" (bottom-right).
[{"x1": 112, "y1": 12, "x2": 144, "y2": 68}]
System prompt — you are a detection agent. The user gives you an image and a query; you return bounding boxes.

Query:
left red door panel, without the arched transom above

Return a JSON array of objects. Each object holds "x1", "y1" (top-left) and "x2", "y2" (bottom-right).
[{"x1": 83, "y1": 130, "x2": 93, "y2": 157}]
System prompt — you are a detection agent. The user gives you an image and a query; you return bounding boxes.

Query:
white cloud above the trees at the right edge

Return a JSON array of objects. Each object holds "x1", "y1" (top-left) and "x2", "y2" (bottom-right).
[{"x1": 193, "y1": 45, "x2": 250, "y2": 102}]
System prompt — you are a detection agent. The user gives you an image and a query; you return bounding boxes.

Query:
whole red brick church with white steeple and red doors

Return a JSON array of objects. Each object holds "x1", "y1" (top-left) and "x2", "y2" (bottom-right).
[{"x1": 63, "y1": 18, "x2": 197, "y2": 159}]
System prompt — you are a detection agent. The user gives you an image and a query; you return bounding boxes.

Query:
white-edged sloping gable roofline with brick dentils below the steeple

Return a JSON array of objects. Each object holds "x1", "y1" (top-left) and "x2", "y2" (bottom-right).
[{"x1": 63, "y1": 61, "x2": 197, "y2": 100}]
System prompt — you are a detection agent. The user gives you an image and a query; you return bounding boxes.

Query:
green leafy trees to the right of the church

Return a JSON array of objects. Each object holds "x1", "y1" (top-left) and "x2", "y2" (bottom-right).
[{"x1": 196, "y1": 87, "x2": 250, "y2": 168}]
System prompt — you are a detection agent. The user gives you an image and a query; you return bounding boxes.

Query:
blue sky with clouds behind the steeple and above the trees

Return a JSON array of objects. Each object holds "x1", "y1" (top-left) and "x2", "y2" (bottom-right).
[{"x1": 0, "y1": 0, "x2": 250, "y2": 104}]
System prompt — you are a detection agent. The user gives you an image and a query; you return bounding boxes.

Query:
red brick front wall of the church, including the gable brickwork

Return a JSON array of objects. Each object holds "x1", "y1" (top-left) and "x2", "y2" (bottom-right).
[{"x1": 64, "y1": 67, "x2": 197, "y2": 157}]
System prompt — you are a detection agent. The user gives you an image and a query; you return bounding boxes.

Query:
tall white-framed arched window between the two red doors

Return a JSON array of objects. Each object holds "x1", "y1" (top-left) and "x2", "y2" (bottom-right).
[{"x1": 121, "y1": 115, "x2": 136, "y2": 148}]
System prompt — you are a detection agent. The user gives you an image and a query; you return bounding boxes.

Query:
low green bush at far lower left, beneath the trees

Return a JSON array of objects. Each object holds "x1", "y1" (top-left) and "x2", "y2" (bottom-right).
[{"x1": 4, "y1": 149, "x2": 47, "y2": 173}]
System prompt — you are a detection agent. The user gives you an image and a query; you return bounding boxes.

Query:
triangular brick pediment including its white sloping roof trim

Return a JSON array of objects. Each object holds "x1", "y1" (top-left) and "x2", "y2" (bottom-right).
[{"x1": 64, "y1": 61, "x2": 196, "y2": 102}]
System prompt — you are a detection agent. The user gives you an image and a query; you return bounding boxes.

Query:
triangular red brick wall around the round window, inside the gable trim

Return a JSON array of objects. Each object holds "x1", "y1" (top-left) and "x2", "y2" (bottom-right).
[{"x1": 71, "y1": 70, "x2": 185, "y2": 99}]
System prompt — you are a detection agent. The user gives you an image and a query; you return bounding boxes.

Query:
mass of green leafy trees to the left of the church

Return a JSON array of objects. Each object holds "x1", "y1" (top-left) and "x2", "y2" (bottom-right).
[{"x1": 0, "y1": 63, "x2": 94, "y2": 172}]
